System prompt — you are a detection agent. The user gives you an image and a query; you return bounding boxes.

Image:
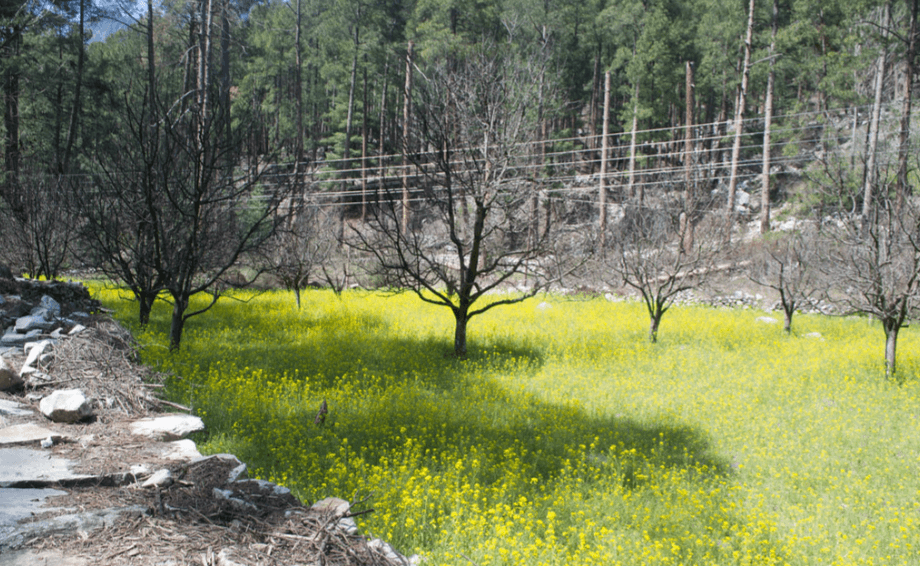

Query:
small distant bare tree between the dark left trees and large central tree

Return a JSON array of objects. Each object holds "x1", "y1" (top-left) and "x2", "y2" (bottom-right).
[{"x1": 261, "y1": 195, "x2": 340, "y2": 309}]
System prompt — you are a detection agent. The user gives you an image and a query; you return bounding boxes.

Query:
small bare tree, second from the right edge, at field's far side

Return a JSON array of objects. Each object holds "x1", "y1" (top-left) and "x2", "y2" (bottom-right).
[{"x1": 748, "y1": 229, "x2": 826, "y2": 334}]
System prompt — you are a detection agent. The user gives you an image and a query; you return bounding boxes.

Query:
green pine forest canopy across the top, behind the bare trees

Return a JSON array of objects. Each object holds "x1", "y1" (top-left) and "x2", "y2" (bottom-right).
[{"x1": 0, "y1": 0, "x2": 913, "y2": 181}]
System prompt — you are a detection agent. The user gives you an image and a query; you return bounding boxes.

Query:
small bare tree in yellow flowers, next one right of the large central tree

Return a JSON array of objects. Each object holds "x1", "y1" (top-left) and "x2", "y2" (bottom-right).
[{"x1": 600, "y1": 200, "x2": 729, "y2": 342}]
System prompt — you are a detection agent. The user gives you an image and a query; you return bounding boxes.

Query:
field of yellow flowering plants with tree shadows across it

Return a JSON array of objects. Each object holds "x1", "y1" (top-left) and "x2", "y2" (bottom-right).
[{"x1": 97, "y1": 290, "x2": 920, "y2": 566}]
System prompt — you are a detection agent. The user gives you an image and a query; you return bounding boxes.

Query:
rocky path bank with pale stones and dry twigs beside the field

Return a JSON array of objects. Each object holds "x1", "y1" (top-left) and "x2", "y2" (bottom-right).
[{"x1": 0, "y1": 278, "x2": 422, "y2": 566}]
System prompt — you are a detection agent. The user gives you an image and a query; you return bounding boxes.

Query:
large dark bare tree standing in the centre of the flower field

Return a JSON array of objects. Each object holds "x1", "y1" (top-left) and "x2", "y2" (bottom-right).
[{"x1": 350, "y1": 46, "x2": 568, "y2": 357}]
